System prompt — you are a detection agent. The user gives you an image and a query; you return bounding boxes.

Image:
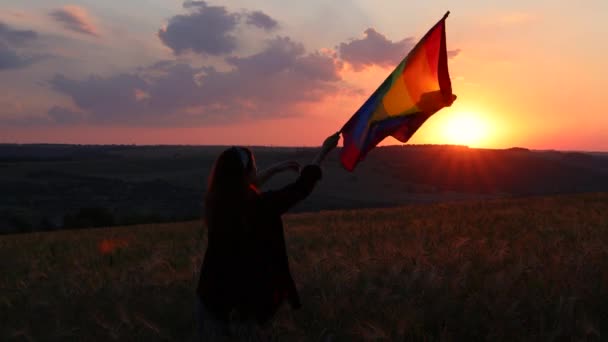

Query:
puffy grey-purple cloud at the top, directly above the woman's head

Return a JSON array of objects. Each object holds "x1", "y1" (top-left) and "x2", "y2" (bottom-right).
[{"x1": 158, "y1": 1, "x2": 239, "y2": 56}]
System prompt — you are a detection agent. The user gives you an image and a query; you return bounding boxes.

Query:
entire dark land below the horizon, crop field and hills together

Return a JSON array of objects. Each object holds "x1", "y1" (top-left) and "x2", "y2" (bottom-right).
[{"x1": 0, "y1": 145, "x2": 608, "y2": 341}]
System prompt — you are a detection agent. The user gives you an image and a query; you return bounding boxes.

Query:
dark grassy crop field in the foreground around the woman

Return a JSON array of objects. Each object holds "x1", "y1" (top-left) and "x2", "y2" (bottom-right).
[{"x1": 0, "y1": 194, "x2": 608, "y2": 341}]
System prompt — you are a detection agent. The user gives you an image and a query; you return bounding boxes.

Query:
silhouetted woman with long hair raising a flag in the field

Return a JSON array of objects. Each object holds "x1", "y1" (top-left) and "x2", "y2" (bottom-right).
[{"x1": 197, "y1": 132, "x2": 340, "y2": 341}]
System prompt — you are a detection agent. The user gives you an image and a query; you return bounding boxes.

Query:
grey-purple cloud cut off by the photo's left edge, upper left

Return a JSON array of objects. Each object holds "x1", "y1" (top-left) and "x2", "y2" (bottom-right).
[{"x1": 0, "y1": 22, "x2": 41, "y2": 70}]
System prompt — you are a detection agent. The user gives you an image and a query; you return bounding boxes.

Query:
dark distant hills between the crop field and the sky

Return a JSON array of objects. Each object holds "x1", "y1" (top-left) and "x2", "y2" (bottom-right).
[{"x1": 0, "y1": 145, "x2": 608, "y2": 233}]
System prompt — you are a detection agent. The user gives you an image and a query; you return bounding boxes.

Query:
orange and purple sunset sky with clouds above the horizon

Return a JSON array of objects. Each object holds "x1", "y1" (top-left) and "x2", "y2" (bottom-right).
[{"x1": 0, "y1": 0, "x2": 608, "y2": 151}]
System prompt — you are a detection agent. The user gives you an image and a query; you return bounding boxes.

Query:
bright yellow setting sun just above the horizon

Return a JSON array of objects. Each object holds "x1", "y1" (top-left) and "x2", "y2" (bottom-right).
[{"x1": 442, "y1": 112, "x2": 488, "y2": 147}]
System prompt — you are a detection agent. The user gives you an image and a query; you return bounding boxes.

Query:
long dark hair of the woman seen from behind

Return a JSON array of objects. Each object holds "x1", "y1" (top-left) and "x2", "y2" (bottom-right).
[{"x1": 204, "y1": 147, "x2": 253, "y2": 231}]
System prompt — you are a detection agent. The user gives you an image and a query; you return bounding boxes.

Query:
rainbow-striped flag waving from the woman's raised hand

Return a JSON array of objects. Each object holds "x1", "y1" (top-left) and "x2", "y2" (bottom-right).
[{"x1": 340, "y1": 12, "x2": 456, "y2": 171}]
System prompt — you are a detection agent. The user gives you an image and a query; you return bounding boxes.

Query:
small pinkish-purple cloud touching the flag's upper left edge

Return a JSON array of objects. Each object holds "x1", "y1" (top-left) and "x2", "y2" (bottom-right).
[{"x1": 337, "y1": 28, "x2": 415, "y2": 70}]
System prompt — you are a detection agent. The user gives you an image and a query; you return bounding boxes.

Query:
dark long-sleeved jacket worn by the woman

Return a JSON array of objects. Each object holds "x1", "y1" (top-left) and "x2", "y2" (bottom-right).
[{"x1": 197, "y1": 165, "x2": 321, "y2": 324}]
